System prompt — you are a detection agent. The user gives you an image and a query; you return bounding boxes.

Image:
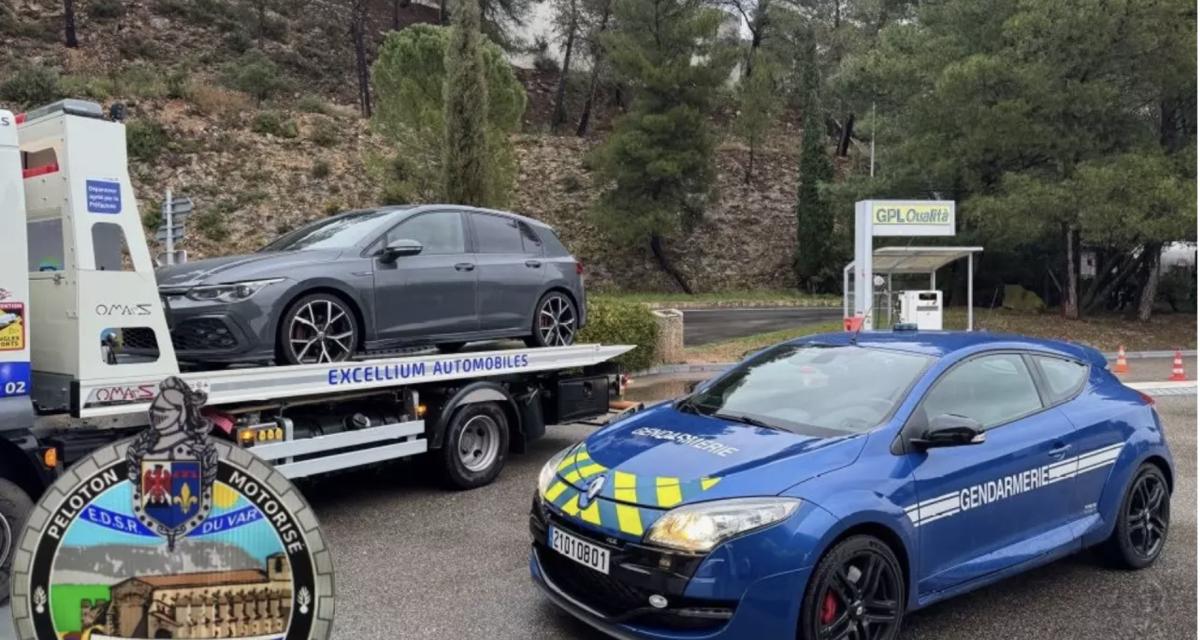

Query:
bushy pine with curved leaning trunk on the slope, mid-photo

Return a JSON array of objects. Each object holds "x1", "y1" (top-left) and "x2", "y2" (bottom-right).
[{"x1": 596, "y1": 0, "x2": 733, "y2": 293}]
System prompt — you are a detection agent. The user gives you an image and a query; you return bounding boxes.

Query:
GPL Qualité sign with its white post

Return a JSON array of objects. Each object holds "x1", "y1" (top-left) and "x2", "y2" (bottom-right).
[{"x1": 854, "y1": 201, "x2": 954, "y2": 329}]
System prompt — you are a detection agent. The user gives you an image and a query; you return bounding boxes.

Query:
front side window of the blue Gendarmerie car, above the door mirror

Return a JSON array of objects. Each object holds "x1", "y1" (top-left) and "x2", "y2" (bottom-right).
[{"x1": 920, "y1": 353, "x2": 1042, "y2": 429}]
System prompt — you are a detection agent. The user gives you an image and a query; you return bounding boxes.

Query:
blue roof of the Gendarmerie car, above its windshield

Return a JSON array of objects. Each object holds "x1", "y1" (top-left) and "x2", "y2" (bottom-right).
[{"x1": 792, "y1": 331, "x2": 1105, "y2": 364}]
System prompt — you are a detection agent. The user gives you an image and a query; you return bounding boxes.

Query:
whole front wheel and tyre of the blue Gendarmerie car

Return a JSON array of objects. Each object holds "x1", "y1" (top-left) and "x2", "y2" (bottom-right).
[{"x1": 798, "y1": 536, "x2": 905, "y2": 640}]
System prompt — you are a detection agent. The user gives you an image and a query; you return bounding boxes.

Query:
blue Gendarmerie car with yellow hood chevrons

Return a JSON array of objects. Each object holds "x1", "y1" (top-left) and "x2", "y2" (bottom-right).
[{"x1": 529, "y1": 333, "x2": 1174, "y2": 640}]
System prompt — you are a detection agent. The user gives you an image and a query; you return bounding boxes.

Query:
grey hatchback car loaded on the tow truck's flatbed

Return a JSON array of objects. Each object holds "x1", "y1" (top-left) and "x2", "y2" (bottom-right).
[{"x1": 136, "y1": 205, "x2": 586, "y2": 364}]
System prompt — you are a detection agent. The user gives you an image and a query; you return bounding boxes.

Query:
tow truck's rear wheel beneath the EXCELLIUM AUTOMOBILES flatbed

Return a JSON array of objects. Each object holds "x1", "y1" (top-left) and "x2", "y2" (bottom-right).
[{"x1": 440, "y1": 402, "x2": 509, "y2": 489}]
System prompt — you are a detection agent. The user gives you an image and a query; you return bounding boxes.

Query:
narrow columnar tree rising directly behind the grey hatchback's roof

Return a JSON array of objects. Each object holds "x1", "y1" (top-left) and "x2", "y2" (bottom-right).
[{"x1": 443, "y1": 0, "x2": 488, "y2": 205}]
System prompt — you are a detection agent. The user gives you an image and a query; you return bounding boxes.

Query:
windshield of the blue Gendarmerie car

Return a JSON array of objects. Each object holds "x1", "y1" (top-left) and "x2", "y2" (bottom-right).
[{"x1": 677, "y1": 345, "x2": 932, "y2": 436}]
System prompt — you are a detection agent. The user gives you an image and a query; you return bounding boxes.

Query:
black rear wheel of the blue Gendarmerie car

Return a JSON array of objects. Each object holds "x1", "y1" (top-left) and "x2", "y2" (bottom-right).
[{"x1": 1105, "y1": 463, "x2": 1171, "y2": 569}]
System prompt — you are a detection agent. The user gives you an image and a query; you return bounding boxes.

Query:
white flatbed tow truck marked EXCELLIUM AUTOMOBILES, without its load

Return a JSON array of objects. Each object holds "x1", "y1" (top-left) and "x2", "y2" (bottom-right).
[{"x1": 0, "y1": 100, "x2": 632, "y2": 602}]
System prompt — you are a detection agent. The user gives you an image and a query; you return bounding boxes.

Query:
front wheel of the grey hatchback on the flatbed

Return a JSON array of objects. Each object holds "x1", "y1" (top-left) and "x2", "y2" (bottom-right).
[{"x1": 278, "y1": 293, "x2": 359, "y2": 364}]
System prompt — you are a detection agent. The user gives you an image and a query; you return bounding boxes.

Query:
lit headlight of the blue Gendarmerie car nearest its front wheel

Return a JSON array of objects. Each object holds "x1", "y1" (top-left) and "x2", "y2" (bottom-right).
[{"x1": 646, "y1": 497, "x2": 802, "y2": 554}]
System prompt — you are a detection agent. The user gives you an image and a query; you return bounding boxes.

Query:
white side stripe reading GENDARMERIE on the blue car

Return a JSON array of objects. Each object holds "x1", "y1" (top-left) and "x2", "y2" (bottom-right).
[{"x1": 905, "y1": 443, "x2": 1124, "y2": 527}]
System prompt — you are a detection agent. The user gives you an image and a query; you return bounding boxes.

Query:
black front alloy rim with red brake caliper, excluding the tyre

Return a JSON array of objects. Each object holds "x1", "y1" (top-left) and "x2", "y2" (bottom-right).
[{"x1": 817, "y1": 549, "x2": 901, "y2": 640}]
